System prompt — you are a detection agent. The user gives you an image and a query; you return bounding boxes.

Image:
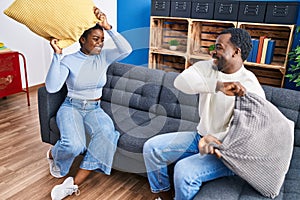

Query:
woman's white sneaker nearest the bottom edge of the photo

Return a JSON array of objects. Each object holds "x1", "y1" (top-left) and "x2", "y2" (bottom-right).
[{"x1": 51, "y1": 177, "x2": 80, "y2": 200}]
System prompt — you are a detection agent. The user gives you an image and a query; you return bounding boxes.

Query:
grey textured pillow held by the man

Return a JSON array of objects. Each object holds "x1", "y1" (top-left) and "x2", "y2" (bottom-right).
[{"x1": 215, "y1": 93, "x2": 294, "y2": 198}]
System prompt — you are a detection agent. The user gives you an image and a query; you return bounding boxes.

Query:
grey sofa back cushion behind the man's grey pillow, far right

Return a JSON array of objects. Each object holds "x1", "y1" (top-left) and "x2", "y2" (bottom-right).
[{"x1": 263, "y1": 85, "x2": 300, "y2": 147}]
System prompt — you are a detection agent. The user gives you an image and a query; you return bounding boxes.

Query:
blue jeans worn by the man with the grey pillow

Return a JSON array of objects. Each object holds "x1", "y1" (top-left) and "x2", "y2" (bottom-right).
[{"x1": 143, "y1": 132, "x2": 234, "y2": 200}]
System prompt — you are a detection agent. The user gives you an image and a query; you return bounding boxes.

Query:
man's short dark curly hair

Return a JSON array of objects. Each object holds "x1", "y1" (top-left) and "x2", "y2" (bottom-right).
[{"x1": 220, "y1": 28, "x2": 252, "y2": 61}]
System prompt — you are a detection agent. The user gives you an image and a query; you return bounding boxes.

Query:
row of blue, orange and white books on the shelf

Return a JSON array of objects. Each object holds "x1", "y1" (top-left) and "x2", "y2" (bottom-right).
[{"x1": 247, "y1": 36, "x2": 276, "y2": 64}]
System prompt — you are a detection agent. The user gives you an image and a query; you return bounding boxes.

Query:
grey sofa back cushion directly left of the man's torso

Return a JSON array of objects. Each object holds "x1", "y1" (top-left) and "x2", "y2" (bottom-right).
[{"x1": 156, "y1": 72, "x2": 199, "y2": 123}]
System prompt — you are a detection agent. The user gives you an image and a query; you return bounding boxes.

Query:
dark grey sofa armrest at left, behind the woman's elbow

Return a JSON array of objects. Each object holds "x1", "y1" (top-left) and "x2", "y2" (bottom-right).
[{"x1": 38, "y1": 86, "x2": 67, "y2": 143}]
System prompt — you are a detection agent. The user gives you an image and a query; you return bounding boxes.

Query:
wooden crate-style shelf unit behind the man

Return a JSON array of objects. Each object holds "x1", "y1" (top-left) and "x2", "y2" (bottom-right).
[{"x1": 149, "y1": 16, "x2": 295, "y2": 87}]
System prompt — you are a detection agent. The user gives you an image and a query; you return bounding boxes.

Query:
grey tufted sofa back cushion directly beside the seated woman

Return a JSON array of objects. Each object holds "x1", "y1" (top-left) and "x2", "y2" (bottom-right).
[{"x1": 102, "y1": 62, "x2": 165, "y2": 111}]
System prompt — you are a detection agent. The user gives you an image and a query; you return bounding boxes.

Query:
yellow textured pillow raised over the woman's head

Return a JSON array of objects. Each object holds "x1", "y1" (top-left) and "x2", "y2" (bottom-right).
[{"x1": 4, "y1": 0, "x2": 99, "y2": 48}]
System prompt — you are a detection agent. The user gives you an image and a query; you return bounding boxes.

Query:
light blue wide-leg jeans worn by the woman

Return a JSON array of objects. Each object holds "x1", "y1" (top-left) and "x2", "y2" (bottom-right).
[{"x1": 51, "y1": 97, "x2": 120, "y2": 176}]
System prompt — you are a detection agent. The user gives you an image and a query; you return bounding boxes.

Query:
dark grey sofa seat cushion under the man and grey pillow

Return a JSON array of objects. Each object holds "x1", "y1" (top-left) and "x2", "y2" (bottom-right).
[{"x1": 194, "y1": 147, "x2": 300, "y2": 200}]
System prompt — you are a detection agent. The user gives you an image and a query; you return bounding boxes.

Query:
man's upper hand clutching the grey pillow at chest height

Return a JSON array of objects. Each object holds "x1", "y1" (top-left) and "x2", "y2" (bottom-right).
[{"x1": 216, "y1": 81, "x2": 246, "y2": 96}]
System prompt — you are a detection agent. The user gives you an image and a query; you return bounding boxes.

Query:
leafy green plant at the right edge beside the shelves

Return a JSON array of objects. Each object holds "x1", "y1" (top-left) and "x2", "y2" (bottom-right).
[{"x1": 286, "y1": 26, "x2": 300, "y2": 87}]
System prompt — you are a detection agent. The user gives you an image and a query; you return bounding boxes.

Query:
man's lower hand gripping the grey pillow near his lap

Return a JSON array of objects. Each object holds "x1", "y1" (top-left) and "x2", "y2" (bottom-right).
[{"x1": 198, "y1": 135, "x2": 222, "y2": 158}]
